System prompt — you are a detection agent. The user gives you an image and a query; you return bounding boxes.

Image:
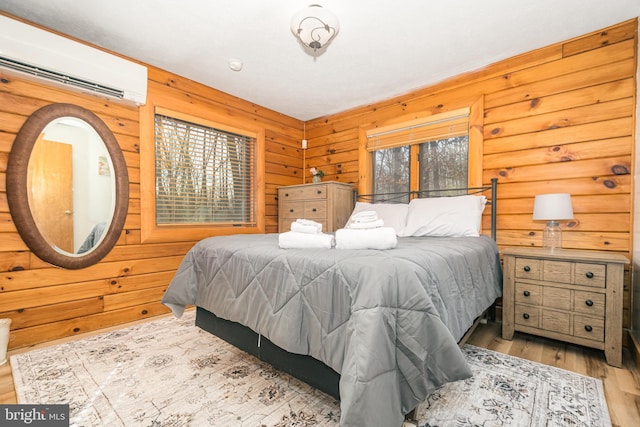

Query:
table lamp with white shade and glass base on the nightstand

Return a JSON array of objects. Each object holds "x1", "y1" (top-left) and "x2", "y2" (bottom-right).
[{"x1": 533, "y1": 193, "x2": 573, "y2": 250}]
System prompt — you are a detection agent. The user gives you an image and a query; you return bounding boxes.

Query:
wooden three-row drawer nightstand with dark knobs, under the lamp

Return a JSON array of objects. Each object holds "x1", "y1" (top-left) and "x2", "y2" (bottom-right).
[{"x1": 502, "y1": 248, "x2": 629, "y2": 367}]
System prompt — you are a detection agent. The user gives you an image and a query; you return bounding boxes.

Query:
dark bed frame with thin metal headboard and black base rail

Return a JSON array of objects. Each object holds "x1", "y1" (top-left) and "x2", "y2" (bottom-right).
[{"x1": 196, "y1": 178, "x2": 498, "y2": 400}]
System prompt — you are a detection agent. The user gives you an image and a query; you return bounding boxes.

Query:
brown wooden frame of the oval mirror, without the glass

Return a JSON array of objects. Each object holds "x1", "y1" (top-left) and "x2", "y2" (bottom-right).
[{"x1": 6, "y1": 104, "x2": 129, "y2": 269}]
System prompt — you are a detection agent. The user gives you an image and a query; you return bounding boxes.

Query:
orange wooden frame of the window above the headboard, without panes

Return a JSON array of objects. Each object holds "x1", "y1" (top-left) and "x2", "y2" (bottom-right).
[{"x1": 358, "y1": 97, "x2": 484, "y2": 194}]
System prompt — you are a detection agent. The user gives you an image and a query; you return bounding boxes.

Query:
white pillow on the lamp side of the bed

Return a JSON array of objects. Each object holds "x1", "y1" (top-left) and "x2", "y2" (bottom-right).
[{"x1": 400, "y1": 196, "x2": 487, "y2": 237}]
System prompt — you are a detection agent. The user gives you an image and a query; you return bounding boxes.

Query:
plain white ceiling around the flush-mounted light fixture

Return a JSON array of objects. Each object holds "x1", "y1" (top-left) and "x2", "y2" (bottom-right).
[{"x1": 0, "y1": 0, "x2": 640, "y2": 120}]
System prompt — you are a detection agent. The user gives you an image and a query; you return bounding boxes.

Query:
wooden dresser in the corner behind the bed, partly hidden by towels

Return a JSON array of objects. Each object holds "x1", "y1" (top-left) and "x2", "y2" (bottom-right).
[{"x1": 278, "y1": 181, "x2": 353, "y2": 233}]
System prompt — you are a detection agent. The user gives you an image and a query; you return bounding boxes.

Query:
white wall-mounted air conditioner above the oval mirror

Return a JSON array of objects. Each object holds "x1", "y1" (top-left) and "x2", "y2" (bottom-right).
[{"x1": 0, "y1": 15, "x2": 147, "y2": 105}]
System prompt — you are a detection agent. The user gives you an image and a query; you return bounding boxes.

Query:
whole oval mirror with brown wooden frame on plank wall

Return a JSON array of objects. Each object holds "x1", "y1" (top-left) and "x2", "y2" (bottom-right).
[{"x1": 7, "y1": 104, "x2": 129, "y2": 269}]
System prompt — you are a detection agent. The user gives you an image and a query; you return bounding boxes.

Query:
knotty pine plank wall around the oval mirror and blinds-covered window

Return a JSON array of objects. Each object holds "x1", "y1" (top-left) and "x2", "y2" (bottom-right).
[{"x1": 0, "y1": 61, "x2": 303, "y2": 348}]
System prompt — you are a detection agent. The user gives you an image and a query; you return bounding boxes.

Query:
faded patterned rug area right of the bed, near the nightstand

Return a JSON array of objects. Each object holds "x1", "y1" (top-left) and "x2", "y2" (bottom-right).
[{"x1": 416, "y1": 345, "x2": 611, "y2": 427}]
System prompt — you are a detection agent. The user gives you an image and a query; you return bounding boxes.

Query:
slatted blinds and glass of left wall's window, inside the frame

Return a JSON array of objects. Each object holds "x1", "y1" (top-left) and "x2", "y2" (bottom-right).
[{"x1": 155, "y1": 113, "x2": 256, "y2": 225}]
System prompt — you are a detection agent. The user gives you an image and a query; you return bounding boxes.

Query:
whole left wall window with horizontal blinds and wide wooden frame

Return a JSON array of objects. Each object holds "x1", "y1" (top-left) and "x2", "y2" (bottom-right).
[{"x1": 141, "y1": 103, "x2": 265, "y2": 243}]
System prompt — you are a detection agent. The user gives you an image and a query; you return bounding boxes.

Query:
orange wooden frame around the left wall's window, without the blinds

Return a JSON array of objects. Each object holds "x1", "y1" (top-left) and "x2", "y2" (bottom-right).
[{"x1": 140, "y1": 97, "x2": 265, "y2": 243}]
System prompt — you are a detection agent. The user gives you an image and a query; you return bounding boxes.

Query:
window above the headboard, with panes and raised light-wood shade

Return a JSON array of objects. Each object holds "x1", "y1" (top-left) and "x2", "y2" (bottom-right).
[{"x1": 359, "y1": 103, "x2": 482, "y2": 202}]
